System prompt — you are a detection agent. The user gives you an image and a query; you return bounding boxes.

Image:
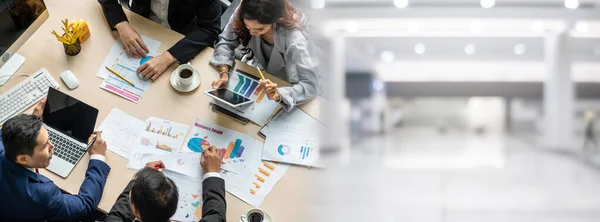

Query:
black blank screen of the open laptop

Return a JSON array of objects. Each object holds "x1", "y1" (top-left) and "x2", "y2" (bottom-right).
[{"x1": 43, "y1": 87, "x2": 98, "y2": 144}]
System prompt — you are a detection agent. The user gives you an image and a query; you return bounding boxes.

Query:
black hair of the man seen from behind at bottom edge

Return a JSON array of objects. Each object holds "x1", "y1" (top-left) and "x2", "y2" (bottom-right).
[{"x1": 131, "y1": 167, "x2": 179, "y2": 222}]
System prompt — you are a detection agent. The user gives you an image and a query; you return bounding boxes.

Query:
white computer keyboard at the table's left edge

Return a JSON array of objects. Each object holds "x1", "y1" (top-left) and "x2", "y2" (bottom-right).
[{"x1": 0, "y1": 68, "x2": 60, "y2": 125}]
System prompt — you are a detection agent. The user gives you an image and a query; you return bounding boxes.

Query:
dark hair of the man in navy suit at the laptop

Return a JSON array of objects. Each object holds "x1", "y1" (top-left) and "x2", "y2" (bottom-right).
[{"x1": 2, "y1": 114, "x2": 42, "y2": 161}]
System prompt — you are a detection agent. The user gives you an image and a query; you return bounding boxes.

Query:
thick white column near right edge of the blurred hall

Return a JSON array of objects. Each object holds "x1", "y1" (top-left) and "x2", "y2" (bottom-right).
[{"x1": 542, "y1": 32, "x2": 577, "y2": 150}]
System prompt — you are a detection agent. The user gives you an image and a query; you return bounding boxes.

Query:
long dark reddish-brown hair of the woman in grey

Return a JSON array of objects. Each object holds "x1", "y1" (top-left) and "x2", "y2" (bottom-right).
[{"x1": 233, "y1": 0, "x2": 301, "y2": 46}]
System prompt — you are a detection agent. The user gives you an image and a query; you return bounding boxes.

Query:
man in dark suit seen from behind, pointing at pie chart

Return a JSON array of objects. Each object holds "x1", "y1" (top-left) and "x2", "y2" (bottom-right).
[{"x1": 105, "y1": 146, "x2": 227, "y2": 222}]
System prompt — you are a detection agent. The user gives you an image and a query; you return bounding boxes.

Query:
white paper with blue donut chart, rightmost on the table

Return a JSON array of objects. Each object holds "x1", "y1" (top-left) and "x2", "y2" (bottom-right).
[{"x1": 260, "y1": 109, "x2": 325, "y2": 166}]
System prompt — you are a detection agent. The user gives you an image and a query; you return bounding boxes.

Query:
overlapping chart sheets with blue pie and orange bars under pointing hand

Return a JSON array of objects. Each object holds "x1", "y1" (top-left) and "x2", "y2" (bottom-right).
[{"x1": 181, "y1": 119, "x2": 290, "y2": 207}]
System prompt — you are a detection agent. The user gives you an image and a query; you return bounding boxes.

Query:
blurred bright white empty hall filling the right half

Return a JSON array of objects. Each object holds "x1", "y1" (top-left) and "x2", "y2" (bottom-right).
[{"x1": 302, "y1": 0, "x2": 600, "y2": 222}]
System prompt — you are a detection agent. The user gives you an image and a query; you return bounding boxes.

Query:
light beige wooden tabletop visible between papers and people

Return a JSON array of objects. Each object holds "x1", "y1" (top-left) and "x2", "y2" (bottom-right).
[{"x1": 0, "y1": 0, "x2": 319, "y2": 221}]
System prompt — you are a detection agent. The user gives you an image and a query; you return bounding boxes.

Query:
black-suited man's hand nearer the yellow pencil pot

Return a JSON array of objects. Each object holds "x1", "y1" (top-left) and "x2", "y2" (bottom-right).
[{"x1": 115, "y1": 21, "x2": 150, "y2": 58}]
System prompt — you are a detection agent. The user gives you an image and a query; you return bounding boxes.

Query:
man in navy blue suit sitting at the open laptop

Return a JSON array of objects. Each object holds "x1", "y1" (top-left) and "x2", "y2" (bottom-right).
[{"x1": 0, "y1": 100, "x2": 110, "y2": 221}]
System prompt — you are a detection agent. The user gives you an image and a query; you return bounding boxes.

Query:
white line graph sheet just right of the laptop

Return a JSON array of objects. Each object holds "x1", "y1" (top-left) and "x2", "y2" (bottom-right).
[{"x1": 98, "y1": 108, "x2": 144, "y2": 159}]
